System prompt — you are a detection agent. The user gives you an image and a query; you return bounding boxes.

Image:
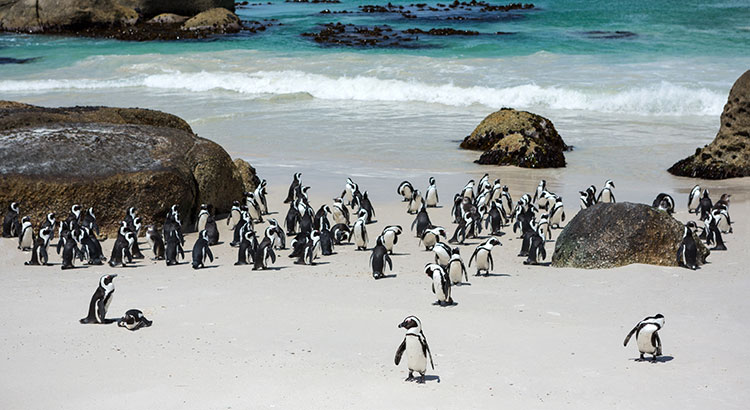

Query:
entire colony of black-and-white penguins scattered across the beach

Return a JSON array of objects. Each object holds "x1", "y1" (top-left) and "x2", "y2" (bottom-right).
[{"x1": 2, "y1": 173, "x2": 732, "y2": 383}]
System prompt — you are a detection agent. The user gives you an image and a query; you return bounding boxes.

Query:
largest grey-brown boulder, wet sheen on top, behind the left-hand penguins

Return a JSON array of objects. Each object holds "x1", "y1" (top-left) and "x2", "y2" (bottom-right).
[{"x1": 0, "y1": 102, "x2": 256, "y2": 232}]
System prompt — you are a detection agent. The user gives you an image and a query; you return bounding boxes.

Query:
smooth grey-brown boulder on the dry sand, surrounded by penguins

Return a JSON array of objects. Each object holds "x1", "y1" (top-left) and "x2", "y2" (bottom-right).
[{"x1": 552, "y1": 202, "x2": 709, "y2": 269}]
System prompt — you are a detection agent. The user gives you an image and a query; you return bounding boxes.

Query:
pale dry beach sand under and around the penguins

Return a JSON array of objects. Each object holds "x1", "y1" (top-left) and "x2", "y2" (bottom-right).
[{"x1": 0, "y1": 180, "x2": 750, "y2": 410}]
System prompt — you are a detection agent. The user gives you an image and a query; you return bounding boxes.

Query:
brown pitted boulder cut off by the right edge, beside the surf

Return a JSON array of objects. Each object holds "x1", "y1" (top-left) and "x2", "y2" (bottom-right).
[{"x1": 669, "y1": 70, "x2": 750, "y2": 179}]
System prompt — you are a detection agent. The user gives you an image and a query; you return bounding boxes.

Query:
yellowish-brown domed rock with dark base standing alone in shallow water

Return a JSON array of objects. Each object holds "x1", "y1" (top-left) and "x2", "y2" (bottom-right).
[{"x1": 461, "y1": 108, "x2": 570, "y2": 168}]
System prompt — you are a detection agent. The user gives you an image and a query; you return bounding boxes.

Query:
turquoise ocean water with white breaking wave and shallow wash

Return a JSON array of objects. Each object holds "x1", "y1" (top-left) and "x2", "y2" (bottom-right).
[{"x1": 0, "y1": 0, "x2": 750, "y2": 200}]
